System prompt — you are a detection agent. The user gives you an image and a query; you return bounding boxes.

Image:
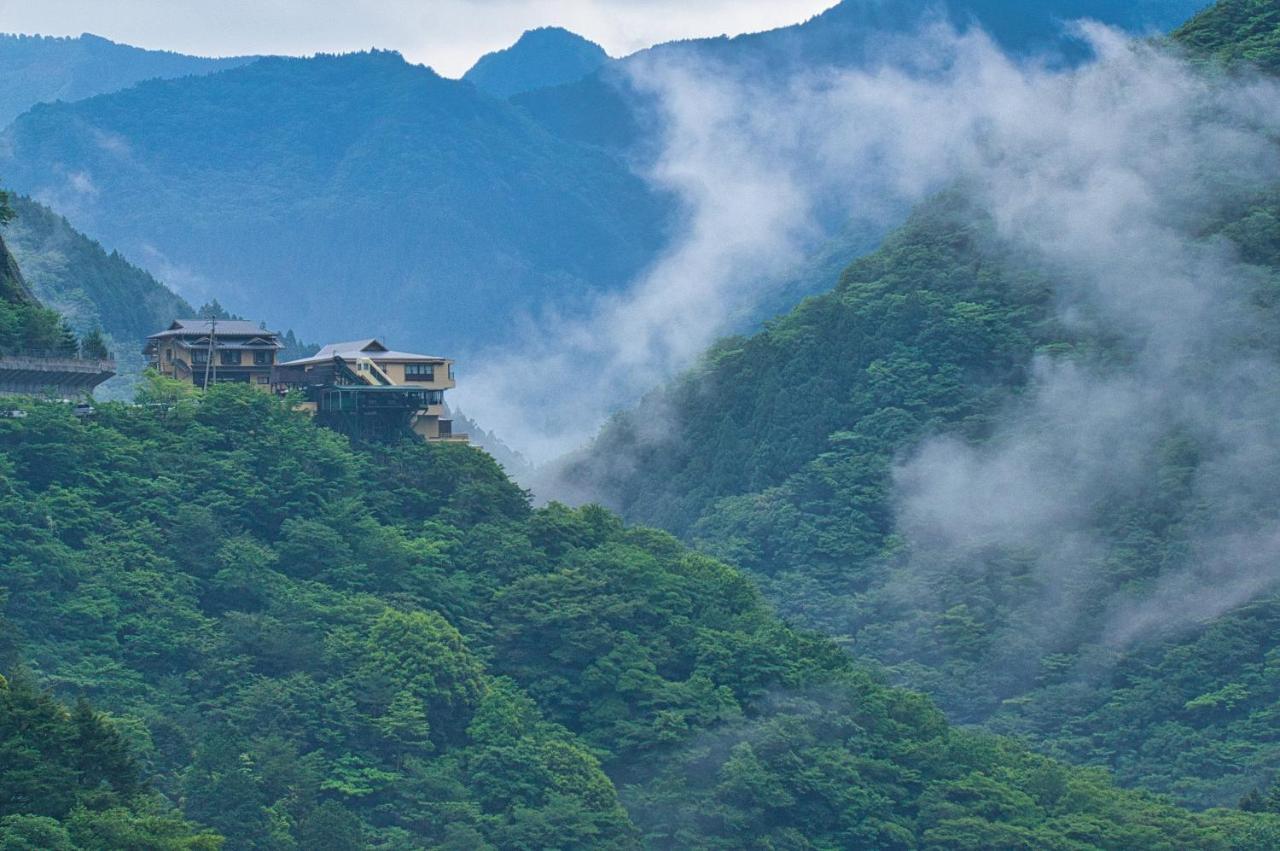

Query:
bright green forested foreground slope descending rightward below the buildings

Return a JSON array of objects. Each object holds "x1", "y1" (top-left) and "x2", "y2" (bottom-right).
[{"x1": 0, "y1": 381, "x2": 1275, "y2": 850}]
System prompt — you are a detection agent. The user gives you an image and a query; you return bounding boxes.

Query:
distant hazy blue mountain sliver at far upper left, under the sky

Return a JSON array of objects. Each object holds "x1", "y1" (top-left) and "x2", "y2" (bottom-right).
[{"x1": 0, "y1": 33, "x2": 253, "y2": 127}]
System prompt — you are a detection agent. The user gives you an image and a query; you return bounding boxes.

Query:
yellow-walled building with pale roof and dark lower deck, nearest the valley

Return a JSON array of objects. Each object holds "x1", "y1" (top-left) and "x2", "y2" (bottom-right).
[{"x1": 271, "y1": 339, "x2": 467, "y2": 441}]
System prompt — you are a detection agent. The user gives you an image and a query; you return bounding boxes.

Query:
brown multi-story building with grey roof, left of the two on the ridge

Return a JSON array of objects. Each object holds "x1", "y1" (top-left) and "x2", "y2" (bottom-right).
[{"x1": 142, "y1": 319, "x2": 284, "y2": 390}]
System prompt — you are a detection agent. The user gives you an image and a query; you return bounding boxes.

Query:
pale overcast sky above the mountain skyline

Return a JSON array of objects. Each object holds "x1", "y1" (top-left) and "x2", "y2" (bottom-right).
[{"x1": 0, "y1": 0, "x2": 836, "y2": 77}]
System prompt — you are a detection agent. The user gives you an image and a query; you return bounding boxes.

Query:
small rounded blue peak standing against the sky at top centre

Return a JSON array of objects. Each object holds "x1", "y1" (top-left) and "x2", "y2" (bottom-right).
[{"x1": 462, "y1": 27, "x2": 609, "y2": 97}]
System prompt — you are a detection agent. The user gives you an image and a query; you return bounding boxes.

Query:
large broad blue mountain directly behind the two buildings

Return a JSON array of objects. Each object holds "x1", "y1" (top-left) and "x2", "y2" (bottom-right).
[{"x1": 0, "y1": 52, "x2": 669, "y2": 353}]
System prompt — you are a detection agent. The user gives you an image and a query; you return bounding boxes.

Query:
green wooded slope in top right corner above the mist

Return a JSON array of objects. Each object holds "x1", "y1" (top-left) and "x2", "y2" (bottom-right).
[{"x1": 1174, "y1": 0, "x2": 1280, "y2": 74}]
